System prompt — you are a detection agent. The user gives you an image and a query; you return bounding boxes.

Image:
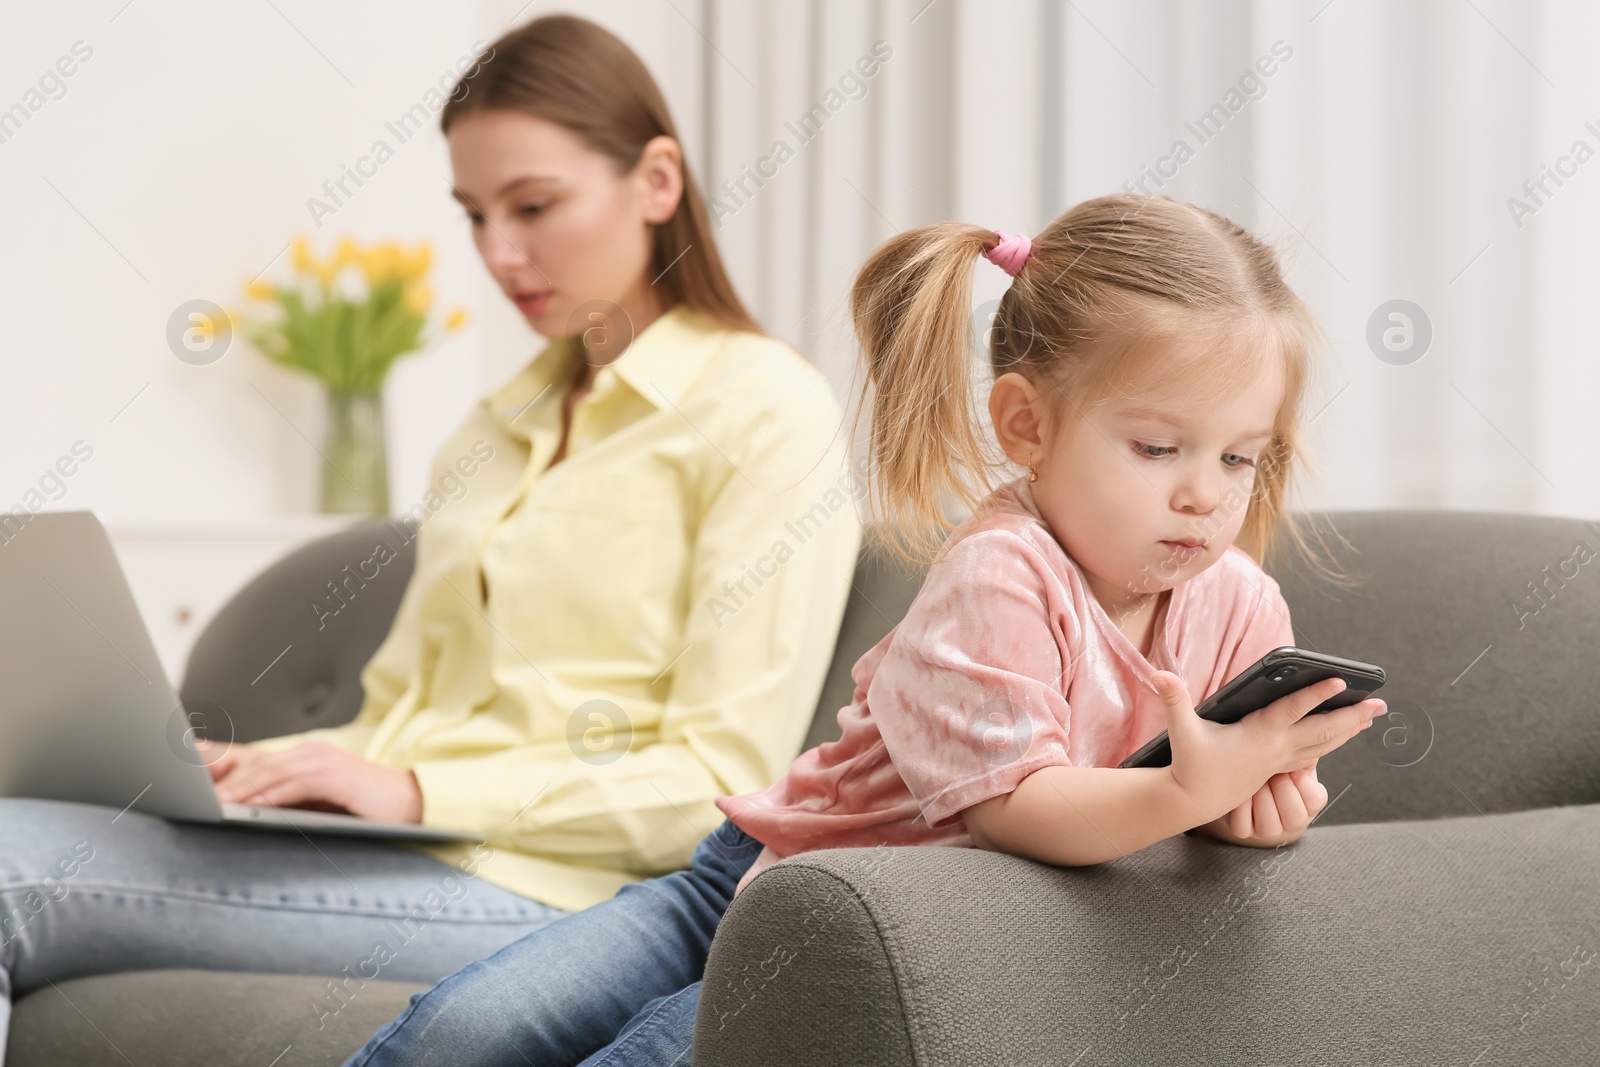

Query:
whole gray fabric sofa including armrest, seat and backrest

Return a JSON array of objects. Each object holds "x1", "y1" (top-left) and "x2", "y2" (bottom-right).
[{"x1": 10, "y1": 510, "x2": 1600, "y2": 1067}]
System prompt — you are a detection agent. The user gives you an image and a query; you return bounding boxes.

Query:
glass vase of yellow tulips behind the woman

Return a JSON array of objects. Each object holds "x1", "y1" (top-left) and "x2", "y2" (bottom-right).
[{"x1": 236, "y1": 237, "x2": 466, "y2": 515}]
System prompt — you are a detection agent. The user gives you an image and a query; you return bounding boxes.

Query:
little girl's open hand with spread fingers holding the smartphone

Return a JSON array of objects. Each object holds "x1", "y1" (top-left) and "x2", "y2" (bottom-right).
[{"x1": 1152, "y1": 670, "x2": 1386, "y2": 829}]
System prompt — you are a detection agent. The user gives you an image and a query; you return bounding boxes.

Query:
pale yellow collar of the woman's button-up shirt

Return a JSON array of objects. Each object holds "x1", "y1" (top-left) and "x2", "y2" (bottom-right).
[{"x1": 485, "y1": 304, "x2": 725, "y2": 422}]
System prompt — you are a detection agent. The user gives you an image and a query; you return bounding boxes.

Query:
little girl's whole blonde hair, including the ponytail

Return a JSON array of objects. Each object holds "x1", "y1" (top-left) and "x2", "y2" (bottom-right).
[{"x1": 850, "y1": 194, "x2": 1349, "y2": 585}]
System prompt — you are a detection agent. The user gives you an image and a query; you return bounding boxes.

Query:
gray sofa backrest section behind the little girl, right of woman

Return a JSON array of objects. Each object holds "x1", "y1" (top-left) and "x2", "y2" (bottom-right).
[{"x1": 806, "y1": 510, "x2": 1600, "y2": 824}]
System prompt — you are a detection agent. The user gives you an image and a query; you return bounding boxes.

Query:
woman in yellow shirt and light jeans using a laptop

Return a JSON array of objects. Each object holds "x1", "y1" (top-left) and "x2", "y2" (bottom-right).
[{"x1": 0, "y1": 10, "x2": 861, "y2": 1048}]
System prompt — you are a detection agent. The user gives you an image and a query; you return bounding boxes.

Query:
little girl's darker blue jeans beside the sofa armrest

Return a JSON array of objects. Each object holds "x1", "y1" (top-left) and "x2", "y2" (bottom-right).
[{"x1": 344, "y1": 821, "x2": 762, "y2": 1067}]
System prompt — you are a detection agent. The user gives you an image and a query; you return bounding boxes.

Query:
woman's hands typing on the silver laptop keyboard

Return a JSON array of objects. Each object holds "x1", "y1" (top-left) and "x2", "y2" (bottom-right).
[{"x1": 195, "y1": 741, "x2": 422, "y2": 822}]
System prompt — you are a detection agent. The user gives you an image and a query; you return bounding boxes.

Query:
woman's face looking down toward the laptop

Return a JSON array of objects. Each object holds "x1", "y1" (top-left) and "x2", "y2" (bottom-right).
[{"x1": 450, "y1": 109, "x2": 683, "y2": 338}]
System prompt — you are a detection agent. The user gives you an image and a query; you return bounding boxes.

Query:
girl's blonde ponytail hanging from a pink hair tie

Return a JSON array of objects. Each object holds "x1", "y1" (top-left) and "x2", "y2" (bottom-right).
[{"x1": 850, "y1": 222, "x2": 998, "y2": 561}]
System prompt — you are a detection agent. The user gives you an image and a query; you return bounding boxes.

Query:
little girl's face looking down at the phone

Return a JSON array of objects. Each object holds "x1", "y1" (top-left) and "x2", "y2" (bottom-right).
[{"x1": 990, "y1": 342, "x2": 1283, "y2": 619}]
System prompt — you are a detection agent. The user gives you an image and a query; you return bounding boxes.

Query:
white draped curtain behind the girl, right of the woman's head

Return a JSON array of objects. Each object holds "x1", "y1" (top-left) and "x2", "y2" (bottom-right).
[{"x1": 521, "y1": 0, "x2": 1600, "y2": 515}]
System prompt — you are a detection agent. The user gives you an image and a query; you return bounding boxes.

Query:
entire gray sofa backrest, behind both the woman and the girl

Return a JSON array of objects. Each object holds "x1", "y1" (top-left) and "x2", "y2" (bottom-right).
[{"x1": 190, "y1": 510, "x2": 1600, "y2": 824}]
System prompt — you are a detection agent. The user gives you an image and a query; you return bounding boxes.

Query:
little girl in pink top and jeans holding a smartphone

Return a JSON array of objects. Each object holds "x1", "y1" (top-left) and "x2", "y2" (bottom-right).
[{"x1": 337, "y1": 195, "x2": 1384, "y2": 1067}]
